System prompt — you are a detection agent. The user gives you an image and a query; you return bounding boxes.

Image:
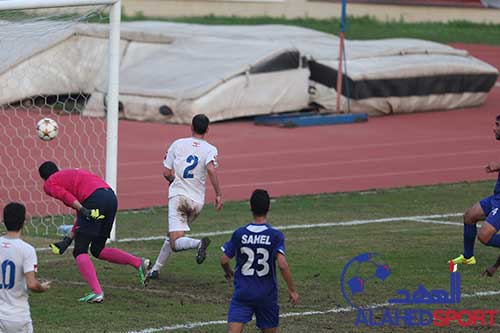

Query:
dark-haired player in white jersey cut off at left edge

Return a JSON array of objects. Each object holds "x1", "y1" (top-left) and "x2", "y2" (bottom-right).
[{"x1": 0, "y1": 202, "x2": 50, "y2": 333}]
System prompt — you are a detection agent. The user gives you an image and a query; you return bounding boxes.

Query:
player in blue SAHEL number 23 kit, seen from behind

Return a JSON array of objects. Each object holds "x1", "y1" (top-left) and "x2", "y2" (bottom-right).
[{"x1": 220, "y1": 190, "x2": 299, "y2": 333}]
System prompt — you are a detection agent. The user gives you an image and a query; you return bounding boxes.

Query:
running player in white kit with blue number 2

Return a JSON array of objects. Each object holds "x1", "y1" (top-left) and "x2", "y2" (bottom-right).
[{"x1": 148, "y1": 114, "x2": 223, "y2": 279}]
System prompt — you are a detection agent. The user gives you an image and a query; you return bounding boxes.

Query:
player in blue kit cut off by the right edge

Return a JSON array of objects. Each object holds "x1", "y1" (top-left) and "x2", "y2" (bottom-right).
[{"x1": 451, "y1": 115, "x2": 500, "y2": 265}]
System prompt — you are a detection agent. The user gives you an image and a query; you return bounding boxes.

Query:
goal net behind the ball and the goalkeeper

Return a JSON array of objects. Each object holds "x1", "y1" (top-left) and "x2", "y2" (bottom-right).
[{"x1": 0, "y1": 1, "x2": 120, "y2": 236}]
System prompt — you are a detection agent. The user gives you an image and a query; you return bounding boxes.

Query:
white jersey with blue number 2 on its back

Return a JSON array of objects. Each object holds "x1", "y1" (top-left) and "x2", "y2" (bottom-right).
[{"x1": 163, "y1": 137, "x2": 217, "y2": 204}]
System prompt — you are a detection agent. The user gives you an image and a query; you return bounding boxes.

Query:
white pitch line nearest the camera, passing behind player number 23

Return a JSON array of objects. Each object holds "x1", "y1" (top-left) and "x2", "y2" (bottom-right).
[{"x1": 128, "y1": 290, "x2": 500, "y2": 333}]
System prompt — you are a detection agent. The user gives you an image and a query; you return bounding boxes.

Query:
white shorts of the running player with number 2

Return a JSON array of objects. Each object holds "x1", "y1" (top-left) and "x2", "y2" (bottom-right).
[{"x1": 168, "y1": 195, "x2": 203, "y2": 232}]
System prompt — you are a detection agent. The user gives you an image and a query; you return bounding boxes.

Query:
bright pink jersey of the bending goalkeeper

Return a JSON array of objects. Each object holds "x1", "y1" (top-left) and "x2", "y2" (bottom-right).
[{"x1": 43, "y1": 169, "x2": 110, "y2": 207}]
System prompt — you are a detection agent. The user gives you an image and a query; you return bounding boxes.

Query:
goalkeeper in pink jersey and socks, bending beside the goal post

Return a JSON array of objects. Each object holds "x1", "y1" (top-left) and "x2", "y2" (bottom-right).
[{"x1": 38, "y1": 161, "x2": 150, "y2": 303}]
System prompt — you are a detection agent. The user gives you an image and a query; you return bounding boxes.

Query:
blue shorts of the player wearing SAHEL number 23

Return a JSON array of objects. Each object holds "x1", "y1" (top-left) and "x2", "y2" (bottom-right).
[{"x1": 227, "y1": 299, "x2": 280, "y2": 329}]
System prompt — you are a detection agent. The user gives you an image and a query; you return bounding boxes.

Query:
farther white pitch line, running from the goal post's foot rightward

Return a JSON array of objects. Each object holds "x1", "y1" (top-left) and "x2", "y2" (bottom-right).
[{"x1": 36, "y1": 213, "x2": 462, "y2": 252}]
